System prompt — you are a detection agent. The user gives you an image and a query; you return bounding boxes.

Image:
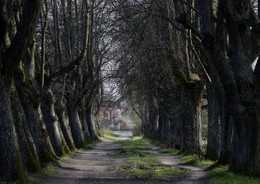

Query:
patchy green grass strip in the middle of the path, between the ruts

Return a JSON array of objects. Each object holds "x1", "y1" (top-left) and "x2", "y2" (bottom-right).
[{"x1": 112, "y1": 137, "x2": 187, "y2": 179}]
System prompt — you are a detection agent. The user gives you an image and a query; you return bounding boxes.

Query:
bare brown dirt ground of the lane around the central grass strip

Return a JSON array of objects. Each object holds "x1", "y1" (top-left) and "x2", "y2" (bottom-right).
[{"x1": 40, "y1": 132, "x2": 208, "y2": 184}]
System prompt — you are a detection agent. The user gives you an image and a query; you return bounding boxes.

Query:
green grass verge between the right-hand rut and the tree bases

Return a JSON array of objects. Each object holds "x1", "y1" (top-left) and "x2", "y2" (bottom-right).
[{"x1": 157, "y1": 148, "x2": 260, "y2": 184}]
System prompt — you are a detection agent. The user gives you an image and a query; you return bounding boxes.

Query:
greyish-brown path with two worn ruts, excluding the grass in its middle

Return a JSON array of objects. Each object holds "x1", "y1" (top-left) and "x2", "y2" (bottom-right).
[{"x1": 42, "y1": 133, "x2": 207, "y2": 184}]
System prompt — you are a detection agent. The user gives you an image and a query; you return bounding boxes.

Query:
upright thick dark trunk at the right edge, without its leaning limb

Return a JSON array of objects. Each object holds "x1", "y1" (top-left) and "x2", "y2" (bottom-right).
[{"x1": 225, "y1": 1, "x2": 260, "y2": 175}]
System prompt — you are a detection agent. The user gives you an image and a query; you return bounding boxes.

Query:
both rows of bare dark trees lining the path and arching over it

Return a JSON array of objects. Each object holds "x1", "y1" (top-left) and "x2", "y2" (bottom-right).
[{"x1": 0, "y1": 0, "x2": 260, "y2": 182}]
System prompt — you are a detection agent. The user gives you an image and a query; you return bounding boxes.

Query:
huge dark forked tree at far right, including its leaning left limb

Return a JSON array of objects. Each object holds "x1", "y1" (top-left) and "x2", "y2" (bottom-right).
[{"x1": 199, "y1": 0, "x2": 260, "y2": 175}]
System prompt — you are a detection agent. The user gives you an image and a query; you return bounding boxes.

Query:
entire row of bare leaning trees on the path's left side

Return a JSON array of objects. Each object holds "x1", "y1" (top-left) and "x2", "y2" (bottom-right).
[{"x1": 0, "y1": 0, "x2": 108, "y2": 182}]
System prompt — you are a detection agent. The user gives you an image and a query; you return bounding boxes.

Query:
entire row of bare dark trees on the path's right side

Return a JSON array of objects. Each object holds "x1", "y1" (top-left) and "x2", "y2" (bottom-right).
[{"x1": 111, "y1": 0, "x2": 260, "y2": 176}]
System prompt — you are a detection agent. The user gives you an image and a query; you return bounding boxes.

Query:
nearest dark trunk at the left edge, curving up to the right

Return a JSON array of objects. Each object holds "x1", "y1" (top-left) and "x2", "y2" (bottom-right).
[{"x1": 0, "y1": 0, "x2": 41, "y2": 181}]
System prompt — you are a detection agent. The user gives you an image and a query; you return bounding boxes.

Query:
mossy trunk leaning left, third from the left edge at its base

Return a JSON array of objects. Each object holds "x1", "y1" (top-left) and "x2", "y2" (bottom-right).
[{"x1": 14, "y1": 69, "x2": 56, "y2": 162}]
